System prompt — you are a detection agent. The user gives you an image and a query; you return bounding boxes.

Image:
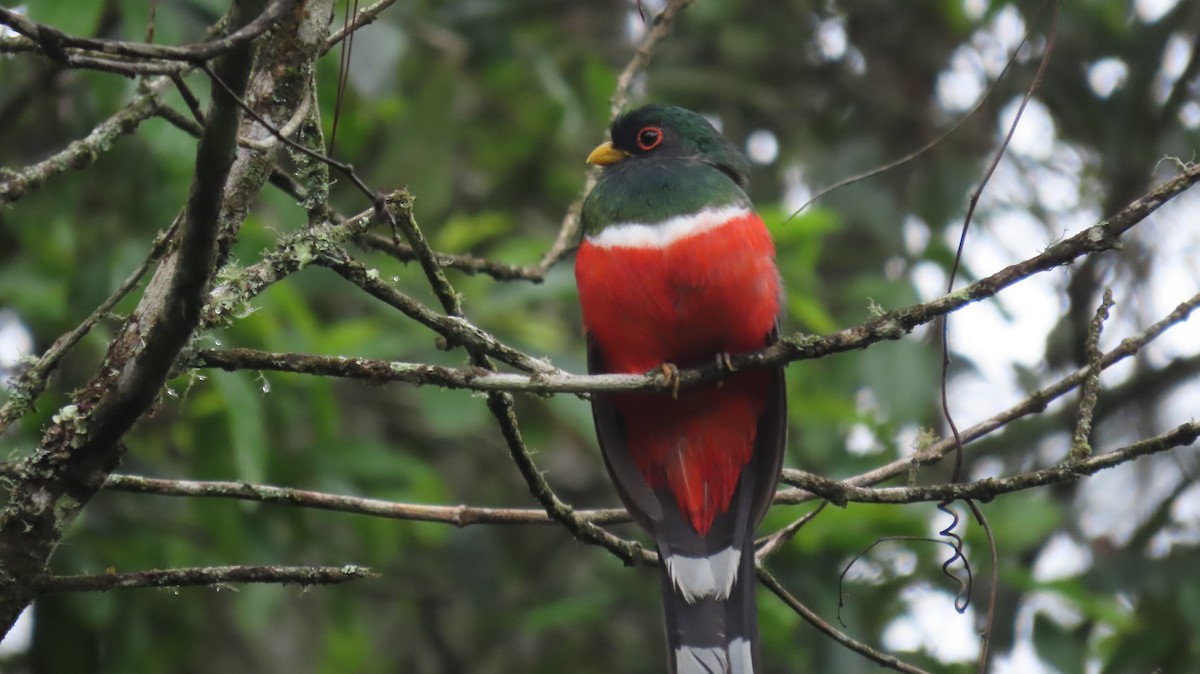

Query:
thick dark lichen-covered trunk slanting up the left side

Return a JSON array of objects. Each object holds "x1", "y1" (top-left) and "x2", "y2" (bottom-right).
[{"x1": 0, "y1": 0, "x2": 263, "y2": 632}]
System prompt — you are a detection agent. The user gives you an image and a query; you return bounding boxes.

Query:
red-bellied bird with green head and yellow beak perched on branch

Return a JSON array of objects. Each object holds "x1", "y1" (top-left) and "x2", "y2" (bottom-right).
[{"x1": 575, "y1": 104, "x2": 787, "y2": 674}]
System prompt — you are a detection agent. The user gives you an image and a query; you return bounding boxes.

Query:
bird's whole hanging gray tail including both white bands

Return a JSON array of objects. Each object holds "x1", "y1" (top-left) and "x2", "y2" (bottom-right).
[{"x1": 660, "y1": 536, "x2": 760, "y2": 674}]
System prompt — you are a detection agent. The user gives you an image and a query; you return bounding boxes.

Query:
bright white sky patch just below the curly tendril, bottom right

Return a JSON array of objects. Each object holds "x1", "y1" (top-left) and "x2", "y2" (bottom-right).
[{"x1": 883, "y1": 583, "x2": 979, "y2": 663}]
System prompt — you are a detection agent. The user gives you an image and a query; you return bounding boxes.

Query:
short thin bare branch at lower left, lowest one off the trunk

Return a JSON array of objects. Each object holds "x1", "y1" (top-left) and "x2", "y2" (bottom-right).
[{"x1": 37, "y1": 564, "x2": 379, "y2": 595}]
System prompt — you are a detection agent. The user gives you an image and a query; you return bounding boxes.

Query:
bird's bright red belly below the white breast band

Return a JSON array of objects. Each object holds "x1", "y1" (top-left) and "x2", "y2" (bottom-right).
[{"x1": 576, "y1": 213, "x2": 780, "y2": 534}]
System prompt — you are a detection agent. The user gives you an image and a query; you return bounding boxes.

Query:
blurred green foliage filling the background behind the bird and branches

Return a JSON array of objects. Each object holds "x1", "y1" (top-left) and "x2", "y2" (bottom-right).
[{"x1": 0, "y1": 0, "x2": 1200, "y2": 674}]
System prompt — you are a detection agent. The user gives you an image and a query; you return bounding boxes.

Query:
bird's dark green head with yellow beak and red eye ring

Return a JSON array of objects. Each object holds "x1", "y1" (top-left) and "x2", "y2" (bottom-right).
[{"x1": 588, "y1": 104, "x2": 749, "y2": 187}]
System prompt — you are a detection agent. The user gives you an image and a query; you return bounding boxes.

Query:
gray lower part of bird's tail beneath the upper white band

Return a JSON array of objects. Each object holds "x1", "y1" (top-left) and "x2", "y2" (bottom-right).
[{"x1": 659, "y1": 536, "x2": 761, "y2": 674}]
